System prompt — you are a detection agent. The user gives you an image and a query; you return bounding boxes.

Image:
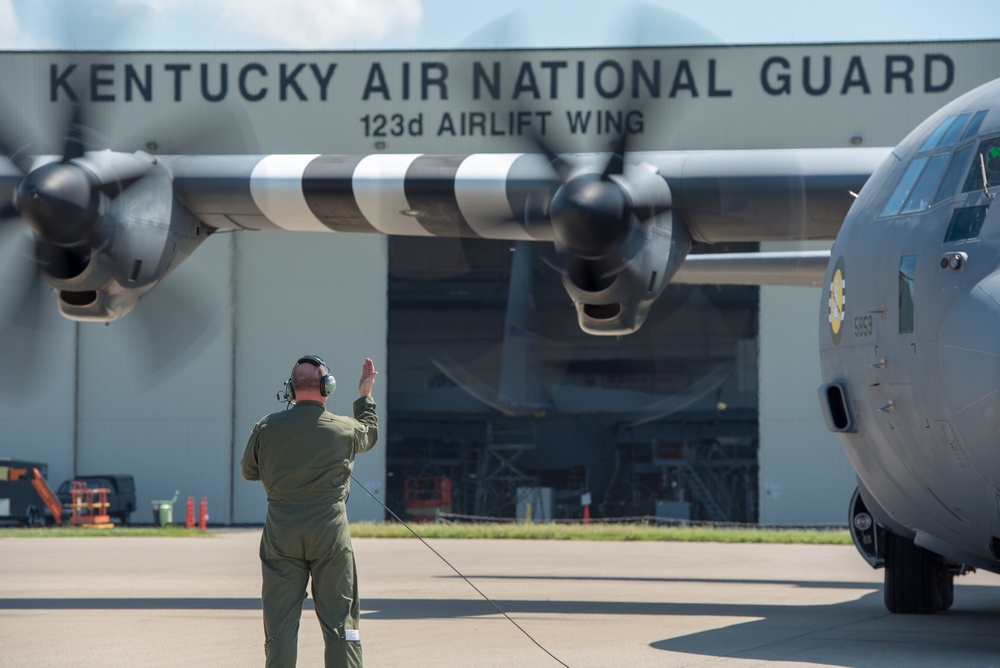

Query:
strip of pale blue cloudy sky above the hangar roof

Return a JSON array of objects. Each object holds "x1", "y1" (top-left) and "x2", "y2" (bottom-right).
[{"x1": 0, "y1": 0, "x2": 1000, "y2": 51}]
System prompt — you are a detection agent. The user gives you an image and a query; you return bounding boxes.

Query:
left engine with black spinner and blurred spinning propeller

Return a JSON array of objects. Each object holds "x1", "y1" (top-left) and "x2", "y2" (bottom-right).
[{"x1": 0, "y1": 104, "x2": 222, "y2": 394}]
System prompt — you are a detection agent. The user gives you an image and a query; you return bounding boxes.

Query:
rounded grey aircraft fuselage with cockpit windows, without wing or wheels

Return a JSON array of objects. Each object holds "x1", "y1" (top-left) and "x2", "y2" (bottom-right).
[{"x1": 820, "y1": 81, "x2": 1000, "y2": 580}]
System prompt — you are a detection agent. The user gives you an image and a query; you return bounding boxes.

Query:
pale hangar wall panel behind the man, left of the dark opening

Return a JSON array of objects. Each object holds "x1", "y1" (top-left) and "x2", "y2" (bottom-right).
[{"x1": 227, "y1": 232, "x2": 388, "y2": 522}]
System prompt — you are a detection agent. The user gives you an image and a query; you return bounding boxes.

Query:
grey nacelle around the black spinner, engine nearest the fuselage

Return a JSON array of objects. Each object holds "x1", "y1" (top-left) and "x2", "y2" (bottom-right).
[{"x1": 563, "y1": 163, "x2": 691, "y2": 336}]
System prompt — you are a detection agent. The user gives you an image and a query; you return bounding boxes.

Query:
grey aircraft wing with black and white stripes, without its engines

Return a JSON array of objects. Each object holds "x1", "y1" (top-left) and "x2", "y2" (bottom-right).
[{"x1": 168, "y1": 148, "x2": 891, "y2": 243}]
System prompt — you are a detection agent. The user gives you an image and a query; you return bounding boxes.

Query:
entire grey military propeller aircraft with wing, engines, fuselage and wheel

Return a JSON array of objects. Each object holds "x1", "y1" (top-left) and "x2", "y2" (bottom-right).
[{"x1": 0, "y1": 39, "x2": 1000, "y2": 613}]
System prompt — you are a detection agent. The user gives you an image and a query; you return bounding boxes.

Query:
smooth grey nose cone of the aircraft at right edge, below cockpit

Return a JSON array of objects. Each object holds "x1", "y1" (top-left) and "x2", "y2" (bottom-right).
[{"x1": 938, "y1": 271, "x2": 1000, "y2": 487}]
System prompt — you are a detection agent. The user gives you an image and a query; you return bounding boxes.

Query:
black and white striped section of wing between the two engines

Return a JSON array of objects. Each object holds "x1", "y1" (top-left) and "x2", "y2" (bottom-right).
[{"x1": 238, "y1": 153, "x2": 558, "y2": 240}]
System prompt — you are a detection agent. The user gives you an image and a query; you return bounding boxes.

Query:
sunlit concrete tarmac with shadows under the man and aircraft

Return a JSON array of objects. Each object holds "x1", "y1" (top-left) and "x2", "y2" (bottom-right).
[{"x1": 0, "y1": 529, "x2": 1000, "y2": 668}]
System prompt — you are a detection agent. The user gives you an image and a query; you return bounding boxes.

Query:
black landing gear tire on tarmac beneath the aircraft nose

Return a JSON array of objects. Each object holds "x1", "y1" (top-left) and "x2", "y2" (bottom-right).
[{"x1": 885, "y1": 532, "x2": 955, "y2": 615}]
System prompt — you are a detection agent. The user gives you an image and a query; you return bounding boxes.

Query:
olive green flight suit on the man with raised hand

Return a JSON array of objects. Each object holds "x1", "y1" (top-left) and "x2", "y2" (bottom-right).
[{"x1": 242, "y1": 397, "x2": 378, "y2": 668}]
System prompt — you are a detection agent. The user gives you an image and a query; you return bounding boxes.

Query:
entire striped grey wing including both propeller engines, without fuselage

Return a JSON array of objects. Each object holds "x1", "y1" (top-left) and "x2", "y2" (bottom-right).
[{"x1": 0, "y1": 146, "x2": 891, "y2": 336}]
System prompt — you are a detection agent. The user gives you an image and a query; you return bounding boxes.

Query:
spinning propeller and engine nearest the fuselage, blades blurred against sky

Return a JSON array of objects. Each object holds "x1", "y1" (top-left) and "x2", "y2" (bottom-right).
[{"x1": 454, "y1": 3, "x2": 718, "y2": 336}]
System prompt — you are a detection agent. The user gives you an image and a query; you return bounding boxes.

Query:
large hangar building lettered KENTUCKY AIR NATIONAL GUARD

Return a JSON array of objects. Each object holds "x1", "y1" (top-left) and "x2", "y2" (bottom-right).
[{"x1": 0, "y1": 42, "x2": 1000, "y2": 524}]
